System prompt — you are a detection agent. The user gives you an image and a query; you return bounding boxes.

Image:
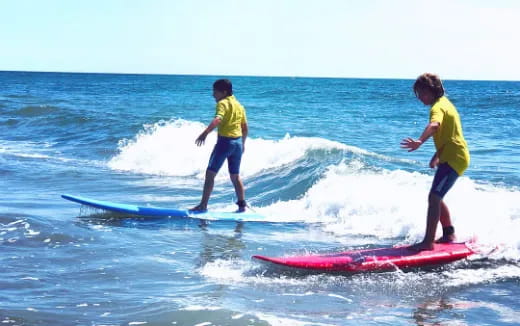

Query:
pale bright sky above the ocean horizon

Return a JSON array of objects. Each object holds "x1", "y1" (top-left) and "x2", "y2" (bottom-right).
[{"x1": 0, "y1": 0, "x2": 520, "y2": 80}]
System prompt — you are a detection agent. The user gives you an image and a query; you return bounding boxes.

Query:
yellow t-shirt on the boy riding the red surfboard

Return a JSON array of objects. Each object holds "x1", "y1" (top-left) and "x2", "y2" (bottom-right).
[{"x1": 430, "y1": 96, "x2": 470, "y2": 175}]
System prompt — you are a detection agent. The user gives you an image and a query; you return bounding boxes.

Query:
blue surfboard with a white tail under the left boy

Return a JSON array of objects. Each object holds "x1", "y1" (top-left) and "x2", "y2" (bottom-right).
[{"x1": 61, "y1": 195, "x2": 265, "y2": 221}]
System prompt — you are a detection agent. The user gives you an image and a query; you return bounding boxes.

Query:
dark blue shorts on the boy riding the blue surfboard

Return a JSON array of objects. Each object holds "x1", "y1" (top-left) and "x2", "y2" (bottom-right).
[{"x1": 208, "y1": 135, "x2": 242, "y2": 174}]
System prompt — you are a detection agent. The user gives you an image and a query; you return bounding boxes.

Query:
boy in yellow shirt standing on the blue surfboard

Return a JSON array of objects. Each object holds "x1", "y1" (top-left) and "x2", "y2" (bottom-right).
[{"x1": 190, "y1": 79, "x2": 248, "y2": 212}]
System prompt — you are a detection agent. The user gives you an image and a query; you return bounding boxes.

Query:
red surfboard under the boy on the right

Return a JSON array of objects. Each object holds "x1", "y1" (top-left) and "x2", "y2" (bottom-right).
[{"x1": 253, "y1": 243, "x2": 475, "y2": 272}]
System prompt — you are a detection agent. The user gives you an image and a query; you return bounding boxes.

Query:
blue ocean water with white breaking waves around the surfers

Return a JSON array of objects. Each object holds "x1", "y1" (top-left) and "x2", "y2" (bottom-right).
[{"x1": 0, "y1": 72, "x2": 520, "y2": 325}]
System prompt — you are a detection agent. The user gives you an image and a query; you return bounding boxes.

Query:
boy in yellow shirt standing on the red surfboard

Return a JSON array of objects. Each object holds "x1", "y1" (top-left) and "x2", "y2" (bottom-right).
[{"x1": 401, "y1": 73, "x2": 470, "y2": 251}]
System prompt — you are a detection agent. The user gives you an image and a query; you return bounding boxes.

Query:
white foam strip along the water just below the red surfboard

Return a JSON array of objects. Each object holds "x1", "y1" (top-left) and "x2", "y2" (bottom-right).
[{"x1": 199, "y1": 259, "x2": 520, "y2": 303}]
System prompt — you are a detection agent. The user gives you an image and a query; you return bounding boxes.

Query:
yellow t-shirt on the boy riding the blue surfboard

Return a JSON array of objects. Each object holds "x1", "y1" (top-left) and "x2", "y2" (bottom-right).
[{"x1": 215, "y1": 95, "x2": 247, "y2": 138}]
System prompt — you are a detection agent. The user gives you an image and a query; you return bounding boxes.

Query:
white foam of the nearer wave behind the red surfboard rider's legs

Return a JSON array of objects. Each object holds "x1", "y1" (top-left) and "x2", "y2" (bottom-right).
[{"x1": 259, "y1": 161, "x2": 520, "y2": 258}]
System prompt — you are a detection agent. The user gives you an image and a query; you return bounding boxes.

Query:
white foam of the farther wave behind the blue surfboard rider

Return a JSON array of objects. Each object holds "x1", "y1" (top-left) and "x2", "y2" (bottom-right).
[{"x1": 108, "y1": 119, "x2": 358, "y2": 179}]
